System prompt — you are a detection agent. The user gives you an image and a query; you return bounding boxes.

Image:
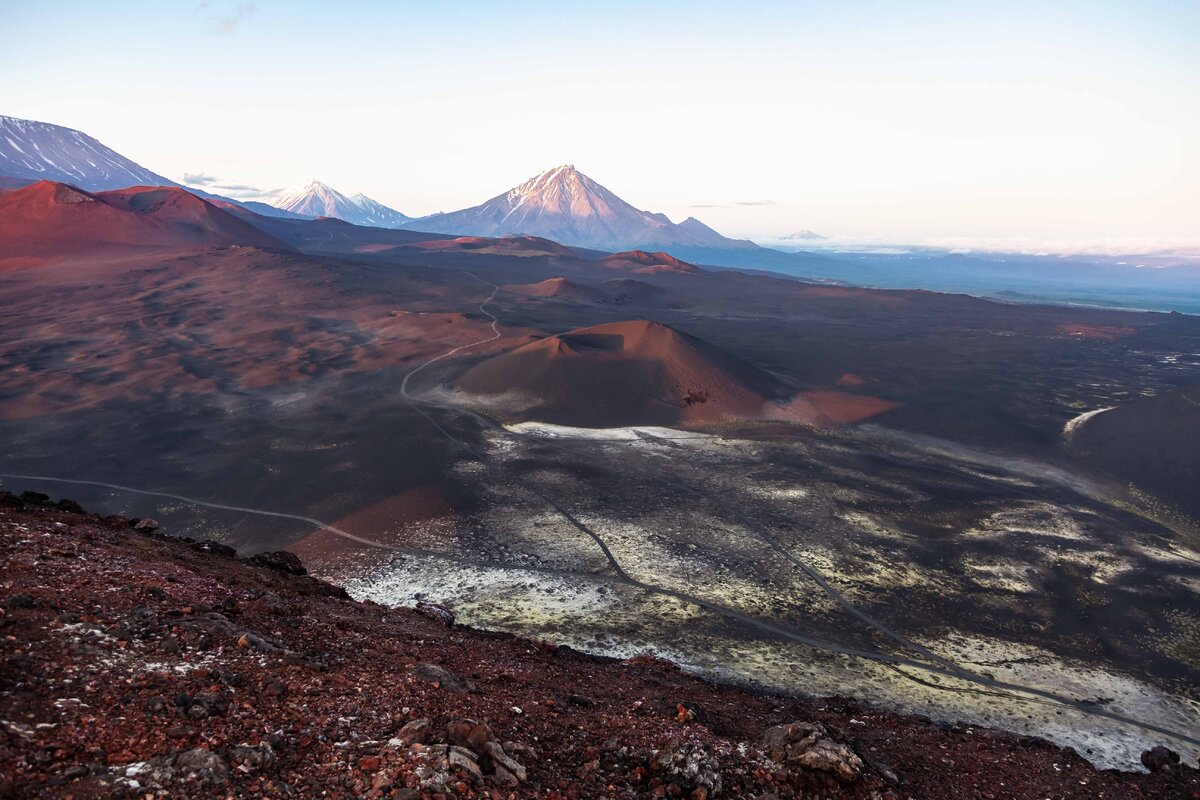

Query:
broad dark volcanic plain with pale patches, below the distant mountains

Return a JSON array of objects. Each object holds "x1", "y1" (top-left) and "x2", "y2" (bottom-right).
[{"x1": 0, "y1": 190, "x2": 1200, "y2": 768}]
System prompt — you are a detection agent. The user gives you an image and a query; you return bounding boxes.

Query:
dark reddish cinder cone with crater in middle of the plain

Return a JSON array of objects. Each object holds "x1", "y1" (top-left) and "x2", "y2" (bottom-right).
[{"x1": 458, "y1": 320, "x2": 784, "y2": 427}]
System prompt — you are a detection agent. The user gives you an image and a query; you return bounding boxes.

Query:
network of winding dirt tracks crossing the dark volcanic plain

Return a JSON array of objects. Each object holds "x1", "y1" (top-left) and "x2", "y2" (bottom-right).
[{"x1": 0, "y1": 272, "x2": 1200, "y2": 746}]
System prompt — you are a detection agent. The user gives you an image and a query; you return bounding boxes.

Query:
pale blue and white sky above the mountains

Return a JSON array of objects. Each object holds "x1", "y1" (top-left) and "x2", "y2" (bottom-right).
[{"x1": 0, "y1": 0, "x2": 1200, "y2": 248}]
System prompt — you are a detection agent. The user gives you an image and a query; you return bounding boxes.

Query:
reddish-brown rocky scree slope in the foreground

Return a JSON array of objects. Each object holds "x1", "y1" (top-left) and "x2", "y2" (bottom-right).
[{"x1": 0, "y1": 493, "x2": 1200, "y2": 800}]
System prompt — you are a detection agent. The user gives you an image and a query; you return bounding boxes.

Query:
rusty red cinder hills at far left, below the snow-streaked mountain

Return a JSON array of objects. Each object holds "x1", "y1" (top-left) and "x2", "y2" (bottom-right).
[{"x1": 0, "y1": 181, "x2": 290, "y2": 263}]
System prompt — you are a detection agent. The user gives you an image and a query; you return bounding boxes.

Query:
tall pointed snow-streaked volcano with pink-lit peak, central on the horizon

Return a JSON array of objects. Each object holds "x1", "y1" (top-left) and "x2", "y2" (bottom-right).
[{"x1": 408, "y1": 164, "x2": 756, "y2": 255}]
